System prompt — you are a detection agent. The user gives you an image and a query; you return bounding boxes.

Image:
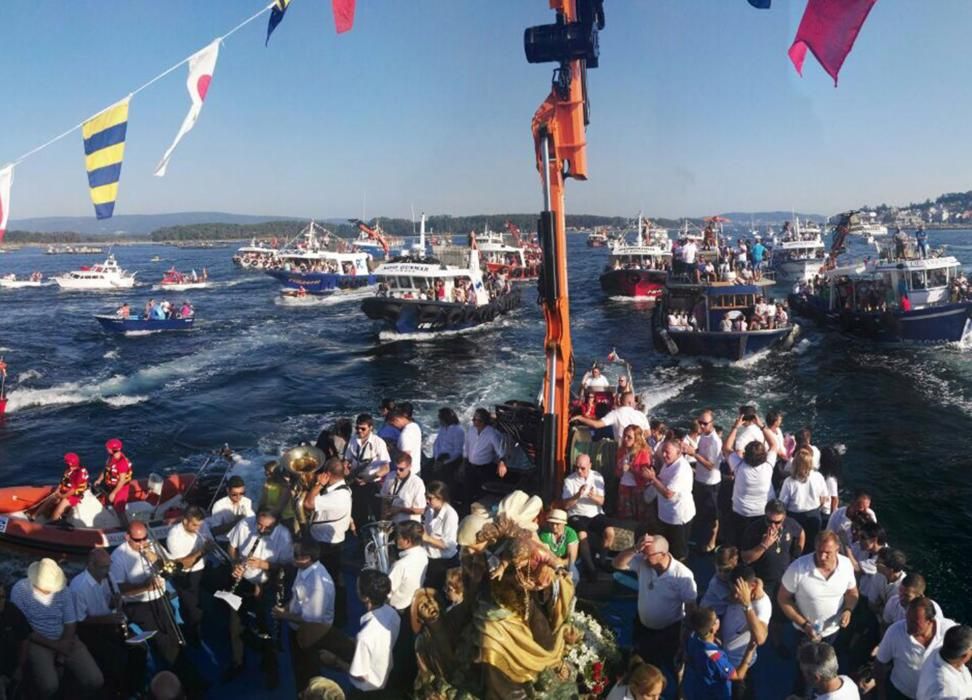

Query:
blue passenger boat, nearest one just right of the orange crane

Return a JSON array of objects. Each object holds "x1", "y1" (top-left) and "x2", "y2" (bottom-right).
[{"x1": 652, "y1": 280, "x2": 800, "y2": 361}]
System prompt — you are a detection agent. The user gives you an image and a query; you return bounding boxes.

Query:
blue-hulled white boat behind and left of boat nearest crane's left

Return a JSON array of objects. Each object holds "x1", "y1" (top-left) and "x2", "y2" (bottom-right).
[{"x1": 266, "y1": 221, "x2": 377, "y2": 296}]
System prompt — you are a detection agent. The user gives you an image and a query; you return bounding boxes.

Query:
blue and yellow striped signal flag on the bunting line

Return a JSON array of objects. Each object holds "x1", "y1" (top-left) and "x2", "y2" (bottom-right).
[{"x1": 81, "y1": 97, "x2": 131, "y2": 219}]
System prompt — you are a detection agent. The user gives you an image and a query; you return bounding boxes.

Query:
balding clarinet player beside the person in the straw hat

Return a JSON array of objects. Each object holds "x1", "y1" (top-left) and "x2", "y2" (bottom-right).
[{"x1": 70, "y1": 548, "x2": 146, "y2": 697}]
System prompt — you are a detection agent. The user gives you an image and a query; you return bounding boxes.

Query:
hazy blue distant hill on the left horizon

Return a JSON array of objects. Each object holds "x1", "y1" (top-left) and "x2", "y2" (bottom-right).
[{"x1": 7, "y1": 211, "x2": 298, "y2": 237}]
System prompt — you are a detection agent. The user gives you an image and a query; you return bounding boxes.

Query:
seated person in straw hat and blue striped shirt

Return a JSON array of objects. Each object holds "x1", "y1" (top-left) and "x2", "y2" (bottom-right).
[{"x1": 10, "y1": 558, "x2": 105, "y2": 700}]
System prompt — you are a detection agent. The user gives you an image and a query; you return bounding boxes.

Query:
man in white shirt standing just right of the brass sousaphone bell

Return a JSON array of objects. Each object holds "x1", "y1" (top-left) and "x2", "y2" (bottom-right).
[{"x1": 304, "y1": 457, "x2": 354, "y2": 627}]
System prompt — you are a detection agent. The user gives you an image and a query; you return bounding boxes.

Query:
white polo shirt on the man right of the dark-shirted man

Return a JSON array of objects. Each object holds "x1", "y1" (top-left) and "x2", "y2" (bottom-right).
[{"x1": 783, "y1": 553, "x2": 857, "y2": 637}]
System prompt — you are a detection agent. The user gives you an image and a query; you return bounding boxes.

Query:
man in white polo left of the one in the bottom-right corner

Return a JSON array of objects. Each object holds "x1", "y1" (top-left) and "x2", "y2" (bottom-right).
[{"x1": 874, "y1": 598, "x2": 956, "y2": 700}]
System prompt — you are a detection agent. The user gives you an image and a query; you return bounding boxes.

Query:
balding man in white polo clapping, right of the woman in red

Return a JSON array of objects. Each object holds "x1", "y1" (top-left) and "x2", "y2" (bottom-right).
[{"x1": 644, "y1": 439, "x2": 695, "y2": 561}]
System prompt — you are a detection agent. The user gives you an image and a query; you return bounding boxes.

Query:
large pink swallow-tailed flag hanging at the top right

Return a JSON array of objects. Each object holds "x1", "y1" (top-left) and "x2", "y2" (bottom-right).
[{"x1": 789, "y1": 0, "x2": 877, "y2": 87}]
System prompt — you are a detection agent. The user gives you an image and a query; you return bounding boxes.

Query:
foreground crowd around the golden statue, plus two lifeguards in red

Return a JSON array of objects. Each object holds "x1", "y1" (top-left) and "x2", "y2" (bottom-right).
[{"x1": 0, "y1": 394, "x2": 972, "y2": 700}]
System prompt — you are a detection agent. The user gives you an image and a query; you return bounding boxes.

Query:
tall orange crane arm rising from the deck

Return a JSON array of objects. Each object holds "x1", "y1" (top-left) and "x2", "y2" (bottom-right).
[{"x1": 524, "y1": 0, "x2": 604, "y2": 503}]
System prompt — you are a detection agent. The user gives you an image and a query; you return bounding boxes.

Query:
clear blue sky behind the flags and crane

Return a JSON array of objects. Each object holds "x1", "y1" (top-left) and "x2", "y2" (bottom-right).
[{"x1": 0, "y1": 0, "x2": 972, "y2": 219}]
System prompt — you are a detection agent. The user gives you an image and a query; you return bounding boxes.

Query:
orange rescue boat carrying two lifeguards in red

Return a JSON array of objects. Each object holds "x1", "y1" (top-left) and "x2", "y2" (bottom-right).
[{"x1": 0, "y1": 474, "x2": 196, "y2": 554}]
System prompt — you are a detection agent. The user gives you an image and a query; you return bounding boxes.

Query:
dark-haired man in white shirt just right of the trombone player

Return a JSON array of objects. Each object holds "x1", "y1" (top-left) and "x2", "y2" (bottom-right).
[{"x1": 165, "y1": 506, "x2": 213, "y2": 642}]
